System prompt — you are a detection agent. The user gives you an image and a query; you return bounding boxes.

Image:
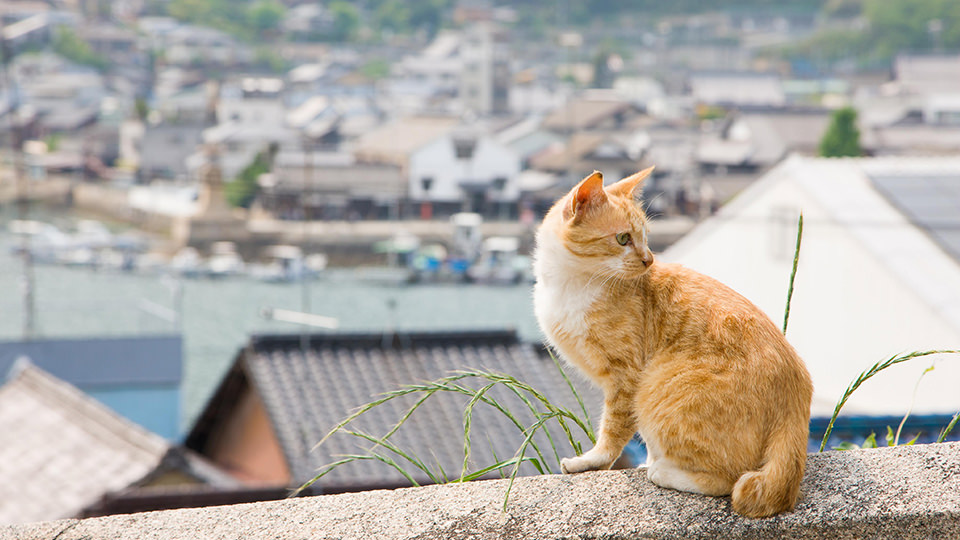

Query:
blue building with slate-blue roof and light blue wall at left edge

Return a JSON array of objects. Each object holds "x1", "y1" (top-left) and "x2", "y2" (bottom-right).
[{"x1": 0, "y1": 336, "x2": 183, "y2": 440}]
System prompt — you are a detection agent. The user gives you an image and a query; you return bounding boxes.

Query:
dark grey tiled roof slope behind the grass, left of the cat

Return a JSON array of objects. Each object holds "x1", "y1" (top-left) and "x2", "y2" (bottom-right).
[{"x1": 241, "y1": 332, "x2": 599, "y2": 492}]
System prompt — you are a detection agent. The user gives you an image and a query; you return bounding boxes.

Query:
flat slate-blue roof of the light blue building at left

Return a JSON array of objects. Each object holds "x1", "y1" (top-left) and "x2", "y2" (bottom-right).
[{"x1": 0, "y1": 335, "x2": 183, "y2": 388}]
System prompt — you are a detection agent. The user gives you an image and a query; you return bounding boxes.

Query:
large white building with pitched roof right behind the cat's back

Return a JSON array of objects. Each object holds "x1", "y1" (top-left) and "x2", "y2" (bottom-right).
[{"x1": 660, "y1": 156, "x2": 960, "y2": 446}]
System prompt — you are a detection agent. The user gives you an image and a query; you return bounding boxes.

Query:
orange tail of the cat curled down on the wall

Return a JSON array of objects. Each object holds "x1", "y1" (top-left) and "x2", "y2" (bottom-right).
[{"x1": 731, "y1": 425, "x2": 807, "y2": 518}]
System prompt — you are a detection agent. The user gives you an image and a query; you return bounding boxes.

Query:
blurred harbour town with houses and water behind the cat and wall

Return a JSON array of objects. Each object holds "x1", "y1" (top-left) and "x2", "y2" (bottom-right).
[{"x1": 0, "y1": 0, "x2": 960, "y2": 523}]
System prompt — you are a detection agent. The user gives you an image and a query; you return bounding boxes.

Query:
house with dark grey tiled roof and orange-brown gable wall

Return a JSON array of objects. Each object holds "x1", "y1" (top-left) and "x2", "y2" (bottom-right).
[{"x1": 186, "y1": 330, "x2": 598, "y2": 493}]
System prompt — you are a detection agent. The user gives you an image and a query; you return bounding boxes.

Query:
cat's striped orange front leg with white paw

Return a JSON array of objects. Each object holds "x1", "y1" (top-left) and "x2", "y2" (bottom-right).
[{"x1": 560, "y1": 391, "x2": 636, "y2": 474}]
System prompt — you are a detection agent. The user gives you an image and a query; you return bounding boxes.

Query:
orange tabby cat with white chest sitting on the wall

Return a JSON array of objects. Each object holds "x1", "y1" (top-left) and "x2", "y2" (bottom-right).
[{"x1": 534, "y1": 167, "x2": 812, "y2": 517}]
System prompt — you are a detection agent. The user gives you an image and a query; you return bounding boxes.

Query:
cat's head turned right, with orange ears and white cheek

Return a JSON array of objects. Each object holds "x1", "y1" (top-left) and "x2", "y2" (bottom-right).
[{"x1": 537, "y1": 167, "x2": 653, "y2": 278}]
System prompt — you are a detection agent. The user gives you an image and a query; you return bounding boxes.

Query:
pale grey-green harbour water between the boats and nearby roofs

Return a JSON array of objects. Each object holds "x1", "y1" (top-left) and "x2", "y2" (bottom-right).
[{"x1": 0, "y1": 223, "x2": 539, "y2": 434}]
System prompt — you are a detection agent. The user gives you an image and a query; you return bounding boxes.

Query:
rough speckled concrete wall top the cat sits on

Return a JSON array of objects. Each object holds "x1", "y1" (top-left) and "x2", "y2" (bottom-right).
[{"x1": 7, "y1": 443, "x2": 960, "y2": 540}]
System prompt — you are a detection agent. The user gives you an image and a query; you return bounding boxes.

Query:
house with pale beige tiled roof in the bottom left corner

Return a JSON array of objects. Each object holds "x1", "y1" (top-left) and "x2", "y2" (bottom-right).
[{"x1": 0, "y1": 361, "x2": 237, "y2": 525}]
